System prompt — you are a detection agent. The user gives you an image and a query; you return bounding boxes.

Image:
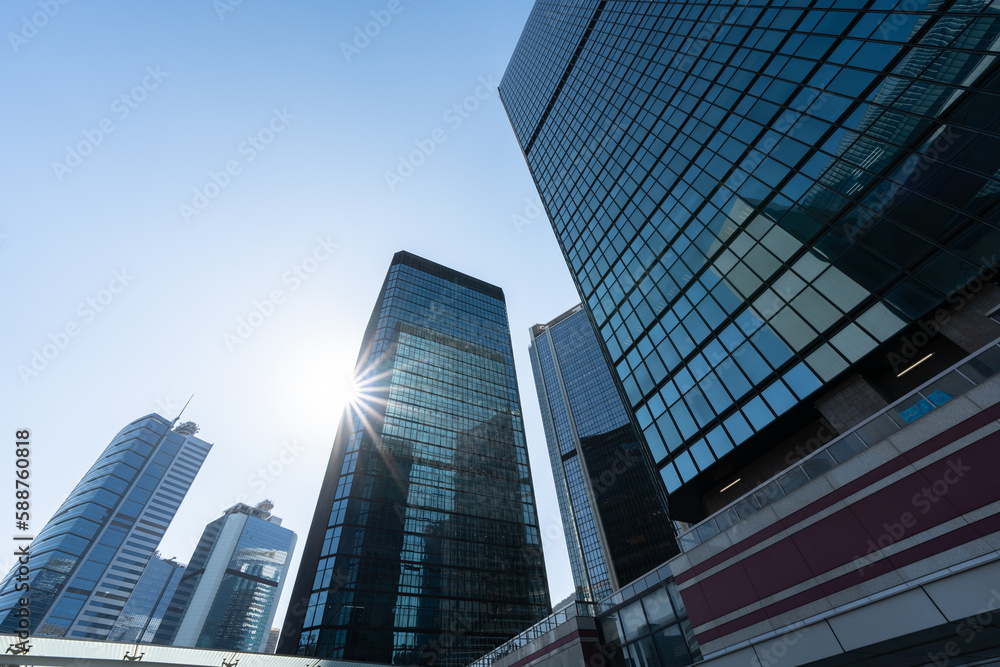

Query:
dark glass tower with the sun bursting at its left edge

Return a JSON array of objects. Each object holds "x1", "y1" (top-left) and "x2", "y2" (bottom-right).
[{"x1": 278, "y1": 252, "x2": 549, "y2": 666}]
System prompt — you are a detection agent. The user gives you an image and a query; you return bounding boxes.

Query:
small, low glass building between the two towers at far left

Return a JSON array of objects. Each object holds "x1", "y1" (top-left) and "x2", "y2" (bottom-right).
[{"x1": 107, "y1": 553, "x2": 184, "y2": 644}]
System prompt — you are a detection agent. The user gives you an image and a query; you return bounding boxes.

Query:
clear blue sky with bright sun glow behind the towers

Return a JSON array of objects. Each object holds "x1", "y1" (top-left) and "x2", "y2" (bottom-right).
[{"x1": 0, "y1": 0, "x2": 578, "y2": 621}]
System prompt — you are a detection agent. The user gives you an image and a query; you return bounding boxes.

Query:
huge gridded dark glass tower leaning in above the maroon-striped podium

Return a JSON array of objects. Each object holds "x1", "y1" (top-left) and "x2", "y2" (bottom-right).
[{"x1": 500, "y1": 0, "x2": 1000, "y2": 521}]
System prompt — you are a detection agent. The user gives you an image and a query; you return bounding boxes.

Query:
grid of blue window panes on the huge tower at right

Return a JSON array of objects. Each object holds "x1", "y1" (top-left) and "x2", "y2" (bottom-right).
[{"x1": 505, "y1": 3, "x2": 996, "y2": 496}]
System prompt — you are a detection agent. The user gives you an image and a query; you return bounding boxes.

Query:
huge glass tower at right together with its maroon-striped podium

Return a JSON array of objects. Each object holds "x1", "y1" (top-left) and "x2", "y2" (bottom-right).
[{"x1": 498, "y1": 0, "x2": 1000, "y2": 667}]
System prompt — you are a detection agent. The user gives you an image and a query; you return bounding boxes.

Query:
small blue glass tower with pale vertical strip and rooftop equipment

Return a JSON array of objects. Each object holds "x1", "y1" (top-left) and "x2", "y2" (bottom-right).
[{"x1": 153, "y1": 501, "x2": 295, "y2": 653}]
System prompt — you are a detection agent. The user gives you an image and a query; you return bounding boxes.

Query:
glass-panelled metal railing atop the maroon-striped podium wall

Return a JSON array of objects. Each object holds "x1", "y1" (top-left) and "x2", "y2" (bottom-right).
[{"x1": 677, "y1": 341, "x2": 1000, "y2": 551}]
